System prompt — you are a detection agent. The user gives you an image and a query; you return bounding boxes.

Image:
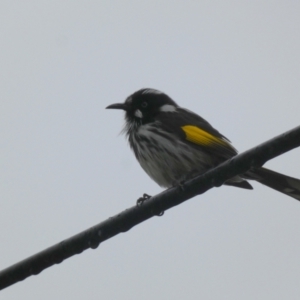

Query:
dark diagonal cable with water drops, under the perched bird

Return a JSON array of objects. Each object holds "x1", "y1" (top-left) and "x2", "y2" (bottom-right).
[{"x1": 0, "y1": 126, "x2": 300, "y2": 290}]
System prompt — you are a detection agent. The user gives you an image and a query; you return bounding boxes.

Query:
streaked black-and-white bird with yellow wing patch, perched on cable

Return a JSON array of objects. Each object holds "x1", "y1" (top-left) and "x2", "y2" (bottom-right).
[{"x1": 106, "y1": 88, "x2": 300, "y2": 200}]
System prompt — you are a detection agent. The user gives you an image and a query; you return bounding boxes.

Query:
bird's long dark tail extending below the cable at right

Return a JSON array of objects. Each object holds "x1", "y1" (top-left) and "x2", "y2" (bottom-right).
[{"x1": 245, "y1": 168, "x2": 300, "y2": 201}]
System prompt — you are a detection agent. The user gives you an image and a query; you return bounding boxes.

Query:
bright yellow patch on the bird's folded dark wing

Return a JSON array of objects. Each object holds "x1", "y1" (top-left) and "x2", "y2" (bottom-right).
[{"x1": 181, "y1": 125, "x2": 231, "y2": 148}]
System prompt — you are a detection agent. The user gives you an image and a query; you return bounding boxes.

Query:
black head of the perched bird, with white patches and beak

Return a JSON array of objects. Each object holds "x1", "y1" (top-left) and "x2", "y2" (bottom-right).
[{"x1": 106, "y1": 88, "x2": 178, "y2": 125}]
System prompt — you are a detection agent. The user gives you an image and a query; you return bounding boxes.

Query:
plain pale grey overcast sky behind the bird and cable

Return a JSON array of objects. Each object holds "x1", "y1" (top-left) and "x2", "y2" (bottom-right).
[{"x1": 0, "y1": 0, "x2": 300, "y2": 300}]
